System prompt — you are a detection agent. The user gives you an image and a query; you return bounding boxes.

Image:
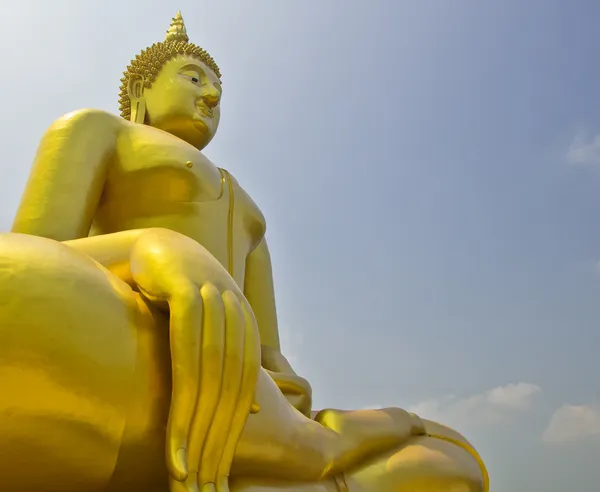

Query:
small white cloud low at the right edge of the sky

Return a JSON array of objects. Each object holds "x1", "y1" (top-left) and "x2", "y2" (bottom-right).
[{"x1": 542, "y1": 404, "x2": 600, "y2": 442}]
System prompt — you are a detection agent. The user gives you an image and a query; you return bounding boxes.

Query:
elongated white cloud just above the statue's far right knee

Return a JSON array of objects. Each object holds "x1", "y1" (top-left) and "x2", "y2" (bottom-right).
[{"x1": 410, "y1": 382, "x2": 541, "y2": 428}]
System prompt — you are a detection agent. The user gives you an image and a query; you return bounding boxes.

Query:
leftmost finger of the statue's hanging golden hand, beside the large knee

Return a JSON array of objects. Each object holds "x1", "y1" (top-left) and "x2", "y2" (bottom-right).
[{"x1": 166, "y1": 288, "x2": 203, "y2": 481}]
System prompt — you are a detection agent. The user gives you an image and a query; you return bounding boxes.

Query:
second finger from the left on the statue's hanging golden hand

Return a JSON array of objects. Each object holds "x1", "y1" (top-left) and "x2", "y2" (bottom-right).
[{"x1": 188, "y1": 284, "x2": 225, "y2": 482}]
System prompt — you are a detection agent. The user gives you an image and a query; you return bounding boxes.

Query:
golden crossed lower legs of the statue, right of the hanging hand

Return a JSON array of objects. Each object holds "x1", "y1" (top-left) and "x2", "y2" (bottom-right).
[{"x1": 234, "y1": 402, "x2": 485, "y2": 492}]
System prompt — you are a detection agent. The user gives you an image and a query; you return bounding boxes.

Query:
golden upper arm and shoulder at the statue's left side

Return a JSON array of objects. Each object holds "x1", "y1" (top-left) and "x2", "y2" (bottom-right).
[{"x1": 12, "y1": 109, "x2": 119, "y2": 241}]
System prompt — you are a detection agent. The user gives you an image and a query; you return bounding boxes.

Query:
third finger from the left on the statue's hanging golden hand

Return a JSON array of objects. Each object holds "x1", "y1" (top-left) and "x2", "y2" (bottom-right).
[{"x1": 198, "y1": 291, "x2": 244, "y2": 487}]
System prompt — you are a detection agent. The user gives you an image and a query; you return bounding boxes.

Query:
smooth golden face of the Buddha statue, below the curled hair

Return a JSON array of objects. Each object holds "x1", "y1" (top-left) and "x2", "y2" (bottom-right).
[{"x1": 143, "y1": 55, "x2": 221, "y2": 149}]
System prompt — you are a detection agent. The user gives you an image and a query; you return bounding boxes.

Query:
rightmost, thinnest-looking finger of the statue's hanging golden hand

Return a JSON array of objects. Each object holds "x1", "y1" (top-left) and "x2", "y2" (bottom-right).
[{"x1": 217, "y1": 302, "x2": 261, "y2": 492}]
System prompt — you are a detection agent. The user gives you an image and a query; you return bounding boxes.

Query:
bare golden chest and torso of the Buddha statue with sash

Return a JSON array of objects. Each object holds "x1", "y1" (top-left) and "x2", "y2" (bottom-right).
[{"x1": 92, "y1": 121, "x2": 265, "y2": 289}]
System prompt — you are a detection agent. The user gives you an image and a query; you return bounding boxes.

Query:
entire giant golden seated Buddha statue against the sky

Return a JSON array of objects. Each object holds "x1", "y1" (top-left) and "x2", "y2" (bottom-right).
[{"x1": 0, "y1": 13, "x2": 489, "y2": 492}]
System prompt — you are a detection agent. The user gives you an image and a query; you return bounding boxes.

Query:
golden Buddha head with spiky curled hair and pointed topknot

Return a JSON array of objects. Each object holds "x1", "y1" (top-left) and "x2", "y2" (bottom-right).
[{"x1": 119, "y1": 12, "x2": 221, "y2": 149}]
